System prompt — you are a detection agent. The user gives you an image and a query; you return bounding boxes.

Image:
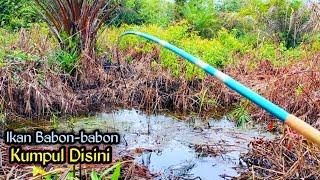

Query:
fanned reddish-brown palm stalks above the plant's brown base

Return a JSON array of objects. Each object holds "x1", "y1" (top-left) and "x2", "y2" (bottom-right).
[{"x1": 34, "y1": 0, "x2": 116, "y2": 76}]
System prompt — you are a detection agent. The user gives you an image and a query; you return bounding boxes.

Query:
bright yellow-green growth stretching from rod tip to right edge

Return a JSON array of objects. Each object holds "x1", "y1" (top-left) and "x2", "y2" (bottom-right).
[{"x1": 98, "y1": 21, "x2": 319, "y2": 79}]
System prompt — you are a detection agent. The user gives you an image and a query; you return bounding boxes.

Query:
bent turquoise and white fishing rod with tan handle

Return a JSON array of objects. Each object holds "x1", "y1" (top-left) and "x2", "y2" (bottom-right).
[{"x1": 120, "y1": 31, "x2": 320, "y2": 146}]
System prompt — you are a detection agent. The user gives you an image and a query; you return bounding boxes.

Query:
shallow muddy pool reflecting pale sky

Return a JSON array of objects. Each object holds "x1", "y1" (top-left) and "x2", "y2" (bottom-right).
[{"x1": 60, "y1": 110, "x2": 272, "y2": 179}]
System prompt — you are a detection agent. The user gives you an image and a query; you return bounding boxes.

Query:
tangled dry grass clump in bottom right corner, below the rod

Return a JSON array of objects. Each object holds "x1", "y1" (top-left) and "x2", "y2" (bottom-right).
[{"x1": 239, "y1": 134, "x2": 320, "y2": 179}]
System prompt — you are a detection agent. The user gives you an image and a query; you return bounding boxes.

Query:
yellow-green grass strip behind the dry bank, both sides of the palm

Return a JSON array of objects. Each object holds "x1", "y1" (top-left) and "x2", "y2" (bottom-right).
[{"x1": 0, "y1": 21, "x2": 320, "y2": 79}]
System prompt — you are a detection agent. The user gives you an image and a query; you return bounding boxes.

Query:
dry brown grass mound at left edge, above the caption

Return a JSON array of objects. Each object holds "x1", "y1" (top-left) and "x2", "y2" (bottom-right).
[{"x1": 0, "y1": 62, "x2": 83, "y2": 118}]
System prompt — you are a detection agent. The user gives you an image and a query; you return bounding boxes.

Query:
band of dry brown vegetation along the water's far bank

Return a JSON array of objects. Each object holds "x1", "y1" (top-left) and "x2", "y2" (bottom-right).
[{"x1": 0, "y1": 46, "x2": 320, "y2": 124}]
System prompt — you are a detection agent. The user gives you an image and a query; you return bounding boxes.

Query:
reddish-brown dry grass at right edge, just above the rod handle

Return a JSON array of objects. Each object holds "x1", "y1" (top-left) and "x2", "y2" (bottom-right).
[{"x1": 226, "y1": 53, "x2": 320, "y2": 127}]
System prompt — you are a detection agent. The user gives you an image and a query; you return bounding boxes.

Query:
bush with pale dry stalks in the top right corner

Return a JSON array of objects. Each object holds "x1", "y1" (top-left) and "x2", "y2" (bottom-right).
[{"x1": 239, "y1": 0, "x2": 311, "y2": 48}]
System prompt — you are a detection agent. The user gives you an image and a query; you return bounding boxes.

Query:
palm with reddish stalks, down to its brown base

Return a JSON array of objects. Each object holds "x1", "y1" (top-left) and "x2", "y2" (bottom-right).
[{"x1": 34, "y1": 0, "x2": 116, "y2": 86}]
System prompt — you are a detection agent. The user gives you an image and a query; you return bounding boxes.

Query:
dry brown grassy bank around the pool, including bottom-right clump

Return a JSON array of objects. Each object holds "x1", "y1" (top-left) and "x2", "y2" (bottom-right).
[{"x1": 0, "y1": 27, "x2": 320, "y2": 178}]
